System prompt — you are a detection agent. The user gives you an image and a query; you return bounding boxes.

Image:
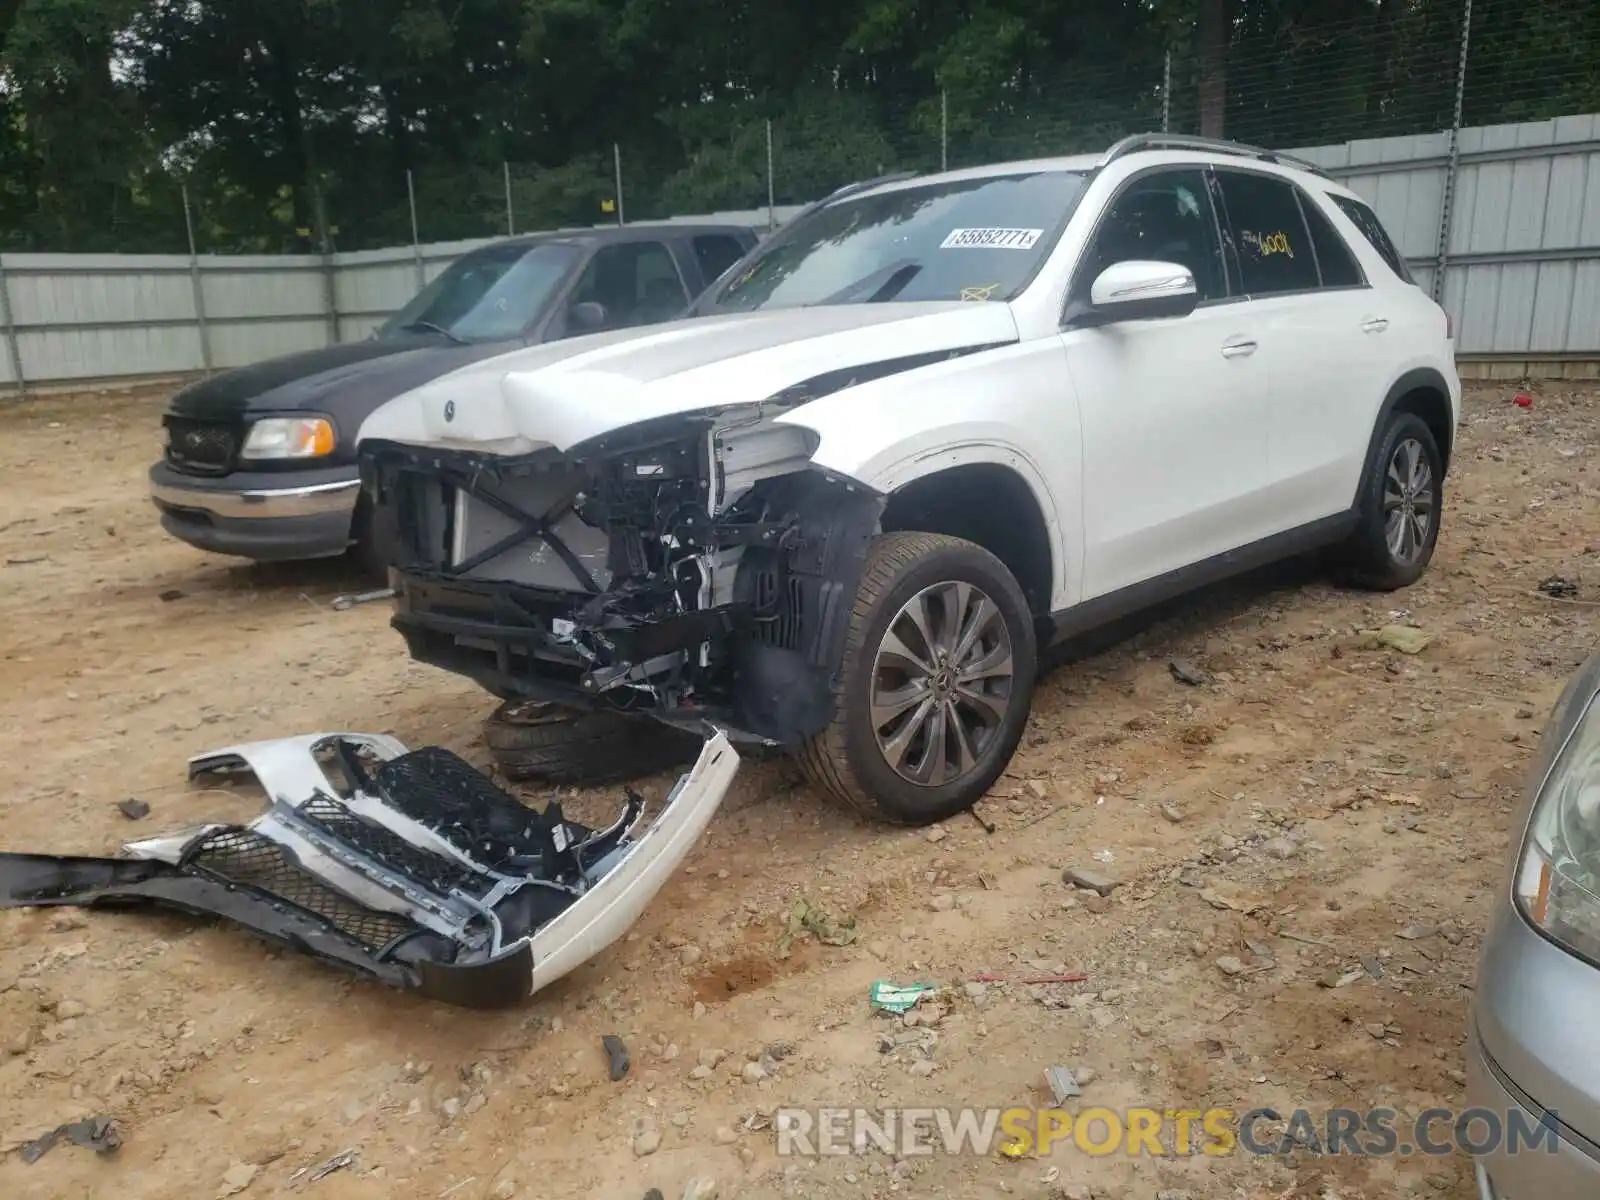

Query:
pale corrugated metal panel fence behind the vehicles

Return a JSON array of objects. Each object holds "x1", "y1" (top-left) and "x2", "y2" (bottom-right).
[{"x1": 0, "y1": 115, "x2": 1600, "y2": 395}]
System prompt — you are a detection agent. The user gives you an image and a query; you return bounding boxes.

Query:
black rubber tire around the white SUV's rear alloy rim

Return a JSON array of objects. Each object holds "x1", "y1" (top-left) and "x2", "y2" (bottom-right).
[{"x1": 1336, "y1": 413, "x2": 1445, "y2": 592}]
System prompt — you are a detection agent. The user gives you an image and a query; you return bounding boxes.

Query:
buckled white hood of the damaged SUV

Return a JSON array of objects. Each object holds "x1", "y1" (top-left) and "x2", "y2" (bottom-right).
[{"x1": 360, "y1": 301, "x2": 1018, "y2": 454}]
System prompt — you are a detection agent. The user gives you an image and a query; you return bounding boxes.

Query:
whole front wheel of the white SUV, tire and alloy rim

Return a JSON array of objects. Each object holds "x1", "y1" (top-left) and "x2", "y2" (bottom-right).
[{"x1": 798, "y1": 533, "x2": 1037, "y2": 826}]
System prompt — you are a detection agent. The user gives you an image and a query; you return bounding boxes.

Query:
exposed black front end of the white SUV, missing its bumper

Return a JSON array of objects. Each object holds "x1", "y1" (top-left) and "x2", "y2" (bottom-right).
[{"x1": 362, "y1": 405, "x2": 883, "y2": 746}]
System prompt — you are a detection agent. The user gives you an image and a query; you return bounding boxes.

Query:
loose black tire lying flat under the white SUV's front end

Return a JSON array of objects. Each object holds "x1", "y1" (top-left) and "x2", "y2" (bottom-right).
[{"x1": 483, "y1": 701, "x2": 701, "y2": 786}]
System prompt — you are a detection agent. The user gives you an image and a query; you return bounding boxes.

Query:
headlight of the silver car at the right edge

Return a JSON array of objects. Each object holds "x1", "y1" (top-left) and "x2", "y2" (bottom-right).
[{"x1": 1515, "y1": 693, "x2": 1600, "y2": 966}]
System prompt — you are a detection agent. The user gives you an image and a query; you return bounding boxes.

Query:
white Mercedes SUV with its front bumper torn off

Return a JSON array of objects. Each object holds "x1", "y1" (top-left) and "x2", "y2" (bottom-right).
[{"x1": 362, "y1": 134, "x2": 1461, "y2": 824}]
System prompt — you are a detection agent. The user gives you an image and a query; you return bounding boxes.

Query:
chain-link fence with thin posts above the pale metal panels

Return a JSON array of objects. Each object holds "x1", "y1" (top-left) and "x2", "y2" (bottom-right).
[{"x1": 12, "y1": 0, "x2": 1600, "y2": 254}]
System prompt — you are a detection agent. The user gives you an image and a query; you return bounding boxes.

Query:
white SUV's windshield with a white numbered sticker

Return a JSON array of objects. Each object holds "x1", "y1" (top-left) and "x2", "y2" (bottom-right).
[{"x1": 714, "y1": 171, "x2": 1083, "y2": 312}]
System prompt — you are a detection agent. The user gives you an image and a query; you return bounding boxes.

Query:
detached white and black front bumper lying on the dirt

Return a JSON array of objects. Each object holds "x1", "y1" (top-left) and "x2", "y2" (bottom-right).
[{"x1": 0, "y1": 733, "x2": 739, "y2": 1008}]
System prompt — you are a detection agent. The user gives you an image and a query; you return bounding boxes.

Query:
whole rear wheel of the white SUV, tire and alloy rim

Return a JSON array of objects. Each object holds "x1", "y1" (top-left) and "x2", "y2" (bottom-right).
[{"x1": 1342, "y1": 413, "x2": 1445, "y2": 592}]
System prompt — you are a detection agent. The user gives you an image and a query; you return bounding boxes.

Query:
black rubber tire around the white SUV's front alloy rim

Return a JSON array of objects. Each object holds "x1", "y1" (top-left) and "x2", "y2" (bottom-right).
[{"x1": 795, "y1": 533, "x2": 1038, "y2": 826}]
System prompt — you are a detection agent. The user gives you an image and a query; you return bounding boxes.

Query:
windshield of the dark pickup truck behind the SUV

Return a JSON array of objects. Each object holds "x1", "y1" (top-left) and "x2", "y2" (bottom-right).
[{"x1": 378, "y1": 243, "x2": 579, "y2": 342}]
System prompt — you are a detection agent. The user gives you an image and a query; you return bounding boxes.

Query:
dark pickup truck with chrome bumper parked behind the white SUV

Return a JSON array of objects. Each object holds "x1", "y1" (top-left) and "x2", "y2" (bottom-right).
[{"x1": 150, "y1": 222, "x2": 757, "y2": 566}]
